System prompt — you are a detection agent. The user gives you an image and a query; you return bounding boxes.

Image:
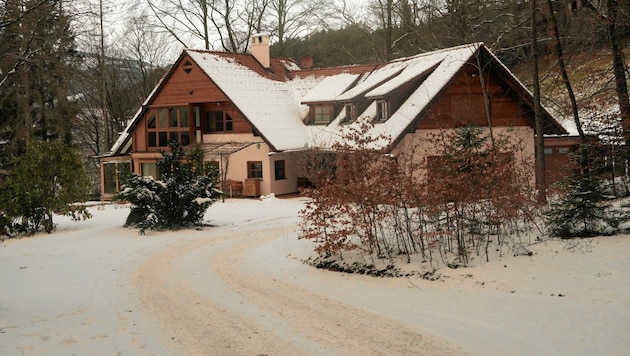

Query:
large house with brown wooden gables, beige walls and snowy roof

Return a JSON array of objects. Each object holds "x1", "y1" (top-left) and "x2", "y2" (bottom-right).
[{"x1": 101, "y1": 34, "x2": 567, "y2": 199}]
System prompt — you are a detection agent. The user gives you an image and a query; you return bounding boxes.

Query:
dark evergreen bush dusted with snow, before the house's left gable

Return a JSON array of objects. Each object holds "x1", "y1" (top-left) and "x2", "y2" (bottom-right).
[{"x1": 117, "y1": 144, "x2": 221, "y2": 233}]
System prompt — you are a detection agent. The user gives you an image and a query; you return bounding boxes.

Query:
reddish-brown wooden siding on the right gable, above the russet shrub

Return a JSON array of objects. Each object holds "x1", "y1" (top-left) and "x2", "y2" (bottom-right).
[{"x1": 417, "y1": 65, "x2": 533, "y2": 129}]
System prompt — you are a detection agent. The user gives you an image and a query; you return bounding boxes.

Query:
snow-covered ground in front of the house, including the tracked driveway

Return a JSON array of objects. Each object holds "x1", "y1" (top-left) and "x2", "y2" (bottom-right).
[{"x1": 0, "y1": 198, "x2": 630, "y2": 355}]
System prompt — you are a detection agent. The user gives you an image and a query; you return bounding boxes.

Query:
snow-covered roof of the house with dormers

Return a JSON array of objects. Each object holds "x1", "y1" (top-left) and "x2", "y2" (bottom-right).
[{"x1": 102, "y1": 43, "x2": 564, "y2": 156}]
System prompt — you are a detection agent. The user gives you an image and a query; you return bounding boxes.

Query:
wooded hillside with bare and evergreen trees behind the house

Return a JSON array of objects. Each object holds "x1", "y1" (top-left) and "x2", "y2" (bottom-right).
[{"x1": 0, "y1": 0, "x2": 630, "y2": 239}]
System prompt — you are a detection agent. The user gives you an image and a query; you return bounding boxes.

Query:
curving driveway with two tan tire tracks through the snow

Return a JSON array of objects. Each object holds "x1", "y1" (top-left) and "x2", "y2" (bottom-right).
[{"x1": 136, "y1": 216, "x2": 461, "y2": 355}]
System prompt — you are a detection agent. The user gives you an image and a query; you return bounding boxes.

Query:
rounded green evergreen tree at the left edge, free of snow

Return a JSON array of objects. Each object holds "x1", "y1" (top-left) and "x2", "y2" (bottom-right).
[{"x1": 0, "y1": 142, "x2": 90, "y2": 233}]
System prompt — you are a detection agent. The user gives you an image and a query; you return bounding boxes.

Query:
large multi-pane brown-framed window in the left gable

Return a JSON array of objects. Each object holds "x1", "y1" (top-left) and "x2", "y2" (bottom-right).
[{"x1": 147, "y1": 106, "x2": 190, "y2": 147}]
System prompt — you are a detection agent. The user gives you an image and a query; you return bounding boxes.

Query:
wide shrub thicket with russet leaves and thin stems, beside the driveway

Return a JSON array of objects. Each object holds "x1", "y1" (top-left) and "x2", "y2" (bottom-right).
[{"x1": 300, "y1": 127, "x2": 537, "y2": 265}]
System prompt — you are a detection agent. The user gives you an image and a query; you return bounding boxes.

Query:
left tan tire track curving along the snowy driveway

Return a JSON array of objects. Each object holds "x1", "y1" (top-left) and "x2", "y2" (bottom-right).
[{"x1": 134, "y1": 227, "x2": 298, "y2": 355}]
